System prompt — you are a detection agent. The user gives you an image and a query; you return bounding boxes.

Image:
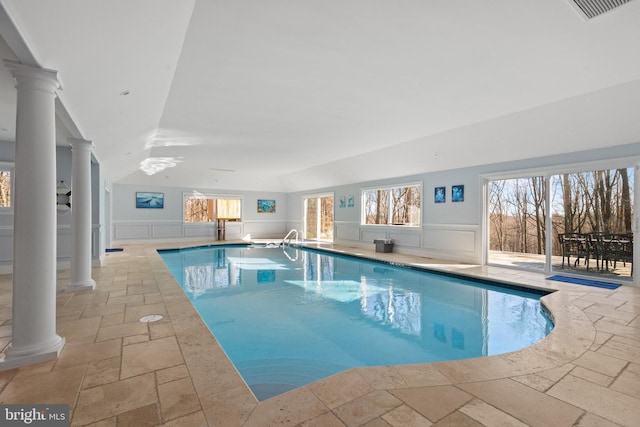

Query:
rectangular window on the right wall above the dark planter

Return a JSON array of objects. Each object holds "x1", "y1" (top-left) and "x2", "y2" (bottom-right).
[{"x1": 362, "y1": 184, "x2": 422, "y2": 227}]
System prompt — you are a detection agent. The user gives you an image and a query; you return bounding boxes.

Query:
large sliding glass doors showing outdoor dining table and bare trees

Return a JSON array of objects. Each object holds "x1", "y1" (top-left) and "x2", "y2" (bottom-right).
[{"x1": 486, "y1": 167, "x2": 634, "y2": 280}]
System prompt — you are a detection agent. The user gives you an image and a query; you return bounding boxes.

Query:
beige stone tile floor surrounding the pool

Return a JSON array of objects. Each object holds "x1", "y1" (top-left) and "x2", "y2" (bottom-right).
[{"x1": 0, "y1": 244, "x2": 640, "y2": 427}]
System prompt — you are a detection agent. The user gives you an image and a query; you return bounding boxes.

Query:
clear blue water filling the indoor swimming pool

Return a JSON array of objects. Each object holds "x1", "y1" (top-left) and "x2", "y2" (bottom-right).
[{"x1": 159, "y1": 245, "x2": 553, "y2": 400}]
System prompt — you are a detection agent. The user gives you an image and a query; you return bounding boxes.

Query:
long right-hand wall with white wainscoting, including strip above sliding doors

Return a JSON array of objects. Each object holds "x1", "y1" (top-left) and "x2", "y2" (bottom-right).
[{"x1": 287, "y1": 143, "x2": 640, "y2": 263}]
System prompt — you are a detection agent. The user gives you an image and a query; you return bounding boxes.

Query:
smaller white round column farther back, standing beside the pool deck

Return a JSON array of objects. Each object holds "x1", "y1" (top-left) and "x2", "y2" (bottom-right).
[{"x1": 67, "y1": 138, "x2": 96, "y2": 292}]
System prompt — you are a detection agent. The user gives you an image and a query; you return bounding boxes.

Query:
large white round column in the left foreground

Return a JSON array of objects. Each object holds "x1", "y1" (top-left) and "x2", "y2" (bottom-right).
[{"x1": 0, "y1": 60, "x2": 64, "y2": 370}]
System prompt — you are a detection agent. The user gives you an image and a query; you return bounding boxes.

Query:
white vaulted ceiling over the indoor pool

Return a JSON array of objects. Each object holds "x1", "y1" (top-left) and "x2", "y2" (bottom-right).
[{"x1": 0, "y1": 0, "x2": 640, "y2": 191}]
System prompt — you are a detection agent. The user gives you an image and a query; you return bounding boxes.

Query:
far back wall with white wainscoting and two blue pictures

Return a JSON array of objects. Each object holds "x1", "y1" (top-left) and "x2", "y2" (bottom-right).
[{"x1": 111, "y1": 184, "x2": 287, "y2": 246}]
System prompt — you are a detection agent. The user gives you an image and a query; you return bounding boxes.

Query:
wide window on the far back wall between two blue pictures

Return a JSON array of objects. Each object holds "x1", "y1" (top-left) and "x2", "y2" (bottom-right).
[{"x1": 184, "y1": 194, "x2": 242, "y2": 222}]
